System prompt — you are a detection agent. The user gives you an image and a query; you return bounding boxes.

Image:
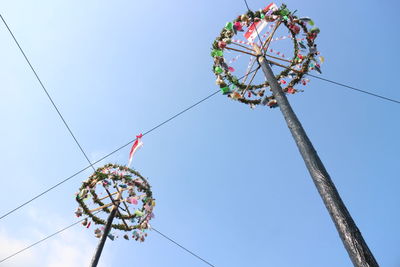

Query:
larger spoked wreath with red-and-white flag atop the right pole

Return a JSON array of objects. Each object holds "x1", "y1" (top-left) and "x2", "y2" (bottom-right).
[{"x1": 211, "y1": 3, "x2": 324, "y2": 108}]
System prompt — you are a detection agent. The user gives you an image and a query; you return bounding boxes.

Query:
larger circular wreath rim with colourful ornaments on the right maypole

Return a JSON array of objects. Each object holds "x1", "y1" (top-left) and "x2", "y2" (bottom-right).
[{"x1": 211, "y1": 4, "x2": 323, "y2": 107}]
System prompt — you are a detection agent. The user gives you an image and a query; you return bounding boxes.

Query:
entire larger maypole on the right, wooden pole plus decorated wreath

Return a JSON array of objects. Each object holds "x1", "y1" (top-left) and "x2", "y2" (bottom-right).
[{"x1": 211, "y1": 4, "x2": 379, "y2": 267}]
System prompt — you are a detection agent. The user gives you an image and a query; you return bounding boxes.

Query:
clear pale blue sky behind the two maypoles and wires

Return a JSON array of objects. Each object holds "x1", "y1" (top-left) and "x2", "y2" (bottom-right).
[{"x1": 0, "y1": 0, "x2": 400, "y2": 267}]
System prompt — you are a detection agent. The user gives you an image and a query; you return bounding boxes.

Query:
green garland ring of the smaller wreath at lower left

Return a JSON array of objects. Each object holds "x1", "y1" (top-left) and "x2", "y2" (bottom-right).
[{"x1": 75, "y1": 164, "x2": 155, "y2": 236}]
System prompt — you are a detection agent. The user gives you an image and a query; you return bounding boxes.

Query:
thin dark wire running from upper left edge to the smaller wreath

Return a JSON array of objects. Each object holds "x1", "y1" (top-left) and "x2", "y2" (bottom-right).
[{"x1": 0, "y1": 14, "x2": 95, "y2": 171}]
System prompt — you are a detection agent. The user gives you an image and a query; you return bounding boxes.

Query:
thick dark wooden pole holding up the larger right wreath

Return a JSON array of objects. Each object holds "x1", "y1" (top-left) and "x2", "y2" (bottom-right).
[{"x1": 255, "y1": 47, "x2": 379, "y2": 267}]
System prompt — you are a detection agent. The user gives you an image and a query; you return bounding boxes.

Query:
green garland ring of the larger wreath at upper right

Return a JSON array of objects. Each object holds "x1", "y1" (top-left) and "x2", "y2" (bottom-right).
[{"x1": 211, "y1": 4, "x2": 320, "y2": 105}]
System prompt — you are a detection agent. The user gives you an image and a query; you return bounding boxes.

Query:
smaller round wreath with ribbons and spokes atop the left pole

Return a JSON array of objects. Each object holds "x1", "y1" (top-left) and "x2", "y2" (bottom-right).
[{"x1": 75, "y1": 164, "x2": 155, "y2": 241}]
